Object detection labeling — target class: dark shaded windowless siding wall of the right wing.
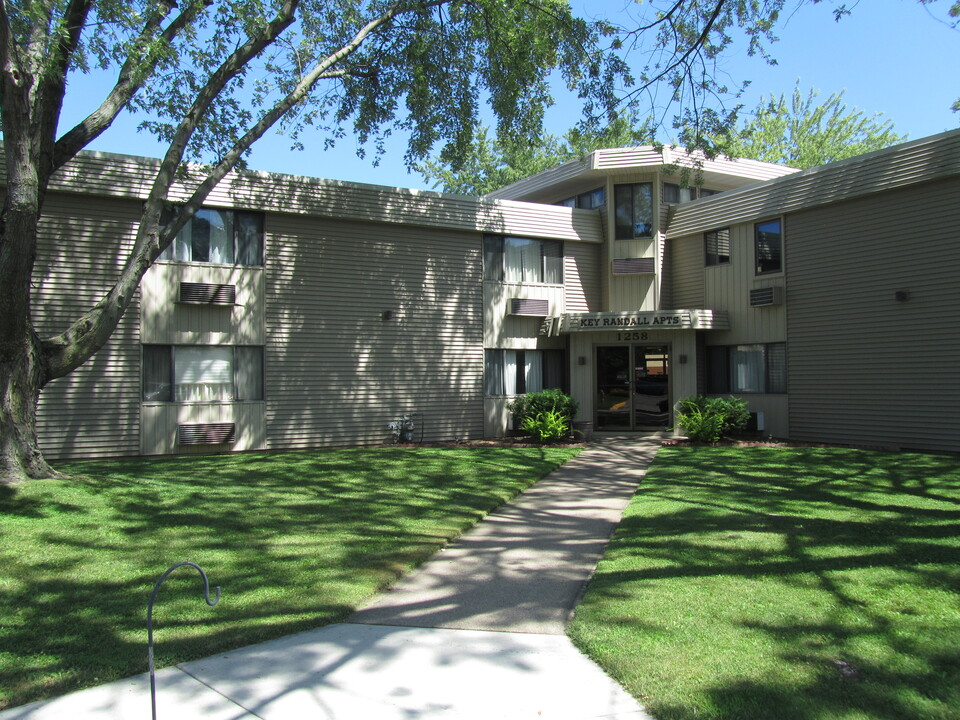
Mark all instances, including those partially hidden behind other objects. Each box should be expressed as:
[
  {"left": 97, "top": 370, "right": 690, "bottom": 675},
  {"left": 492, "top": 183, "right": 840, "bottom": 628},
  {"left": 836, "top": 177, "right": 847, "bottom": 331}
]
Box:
[{"left": 786, "top": 177, "right": 960, "bottom": 452}]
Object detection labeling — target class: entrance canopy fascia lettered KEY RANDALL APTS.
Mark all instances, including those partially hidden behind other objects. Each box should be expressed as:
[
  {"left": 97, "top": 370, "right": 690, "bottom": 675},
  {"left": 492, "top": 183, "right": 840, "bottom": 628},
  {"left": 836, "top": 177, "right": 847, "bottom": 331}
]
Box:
[{"left": 540, "top": 309, "right": 730, "bottom": 336}]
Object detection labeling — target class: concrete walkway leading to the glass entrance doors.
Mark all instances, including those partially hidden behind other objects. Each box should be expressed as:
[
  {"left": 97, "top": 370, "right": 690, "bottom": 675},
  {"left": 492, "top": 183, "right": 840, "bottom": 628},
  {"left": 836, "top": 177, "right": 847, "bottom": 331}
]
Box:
[{"left": 0, "top": 435, "right": 661, "bottom": 720}]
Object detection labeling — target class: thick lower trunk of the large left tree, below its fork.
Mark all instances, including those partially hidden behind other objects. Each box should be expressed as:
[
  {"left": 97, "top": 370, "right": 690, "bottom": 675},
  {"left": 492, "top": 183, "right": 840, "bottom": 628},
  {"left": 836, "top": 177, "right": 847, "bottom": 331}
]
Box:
[{"left": 0, "top": 332, "right": 59, "bottom": 485}]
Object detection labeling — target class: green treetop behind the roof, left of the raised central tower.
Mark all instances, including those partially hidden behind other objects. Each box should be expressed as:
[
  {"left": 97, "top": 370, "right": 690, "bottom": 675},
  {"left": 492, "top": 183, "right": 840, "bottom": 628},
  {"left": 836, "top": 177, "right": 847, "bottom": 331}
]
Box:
[{"left": 416, "top": 118, "right": 649, "bottom": 195}]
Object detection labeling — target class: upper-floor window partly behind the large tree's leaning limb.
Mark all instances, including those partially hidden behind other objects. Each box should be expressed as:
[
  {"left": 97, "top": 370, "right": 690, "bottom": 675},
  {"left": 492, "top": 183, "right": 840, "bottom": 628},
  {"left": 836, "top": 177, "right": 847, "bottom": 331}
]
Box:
[{"left": 160, "top": 208, "right": 263, "bottom": 265}]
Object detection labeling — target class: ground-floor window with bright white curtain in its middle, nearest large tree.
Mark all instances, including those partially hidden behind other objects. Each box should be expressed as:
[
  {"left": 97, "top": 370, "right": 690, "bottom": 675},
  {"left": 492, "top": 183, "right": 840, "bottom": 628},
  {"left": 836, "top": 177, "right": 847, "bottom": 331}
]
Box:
[{"left": 143, "top": 345, "right": 263, "bottom": 402}]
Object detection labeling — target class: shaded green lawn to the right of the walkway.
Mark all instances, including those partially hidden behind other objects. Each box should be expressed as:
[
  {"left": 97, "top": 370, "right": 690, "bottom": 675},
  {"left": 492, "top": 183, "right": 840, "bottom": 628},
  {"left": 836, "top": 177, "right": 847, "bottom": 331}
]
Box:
[{"left": 569, "top": 447, "right": 960, "bottom": 720}]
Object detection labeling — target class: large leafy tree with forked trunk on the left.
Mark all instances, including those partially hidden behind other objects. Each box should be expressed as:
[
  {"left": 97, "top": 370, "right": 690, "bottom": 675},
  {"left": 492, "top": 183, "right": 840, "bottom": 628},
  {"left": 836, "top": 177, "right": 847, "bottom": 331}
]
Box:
[{"left": 0, "top": 0, "right": 625, "bottom": 482}]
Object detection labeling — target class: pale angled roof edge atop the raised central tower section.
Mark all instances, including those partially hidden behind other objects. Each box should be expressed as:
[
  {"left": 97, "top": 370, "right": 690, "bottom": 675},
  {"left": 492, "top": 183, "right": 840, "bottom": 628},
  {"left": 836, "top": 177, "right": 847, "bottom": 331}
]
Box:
[{"left": 484, "top": 145, "right": 798, "bottom": 202}]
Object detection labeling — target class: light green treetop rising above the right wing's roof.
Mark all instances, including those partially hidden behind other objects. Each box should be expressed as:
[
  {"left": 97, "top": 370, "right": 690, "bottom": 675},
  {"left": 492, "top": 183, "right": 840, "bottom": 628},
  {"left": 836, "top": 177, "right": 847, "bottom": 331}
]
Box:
[{"left": 725, "top": 87, "right": 905, "bottom": 168}]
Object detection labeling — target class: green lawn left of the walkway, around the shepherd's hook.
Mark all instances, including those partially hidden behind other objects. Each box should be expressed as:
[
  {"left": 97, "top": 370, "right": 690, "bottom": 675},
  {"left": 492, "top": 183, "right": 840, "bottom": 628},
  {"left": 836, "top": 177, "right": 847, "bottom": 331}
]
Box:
[{"left": 0, "top": 448, "right": 576, "bottom": 708}]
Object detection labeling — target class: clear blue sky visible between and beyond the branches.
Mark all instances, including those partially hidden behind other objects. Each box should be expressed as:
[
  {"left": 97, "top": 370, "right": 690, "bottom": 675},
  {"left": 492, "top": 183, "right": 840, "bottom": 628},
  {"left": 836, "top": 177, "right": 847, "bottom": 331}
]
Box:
[{"left": 62, "top": 0, "right": 960, "bottom": 188}]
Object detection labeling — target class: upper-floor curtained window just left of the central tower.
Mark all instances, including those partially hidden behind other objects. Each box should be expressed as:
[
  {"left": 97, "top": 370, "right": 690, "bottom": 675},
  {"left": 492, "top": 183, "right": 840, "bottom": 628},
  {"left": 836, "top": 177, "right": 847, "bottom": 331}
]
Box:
[{"left": 483, "top": 235, "right": 563, "bottom": 285}]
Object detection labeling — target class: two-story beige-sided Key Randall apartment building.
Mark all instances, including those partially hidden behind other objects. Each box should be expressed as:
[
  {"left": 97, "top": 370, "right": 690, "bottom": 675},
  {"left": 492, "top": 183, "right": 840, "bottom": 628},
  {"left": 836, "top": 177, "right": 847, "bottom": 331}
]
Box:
[{"left": 28, "top": 132, "right": 960, "bottom": 459}]
